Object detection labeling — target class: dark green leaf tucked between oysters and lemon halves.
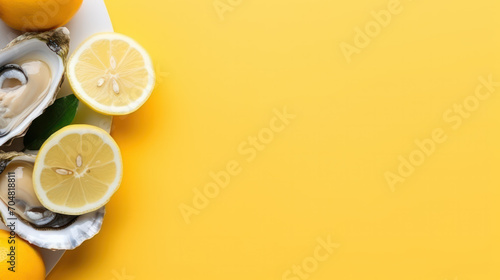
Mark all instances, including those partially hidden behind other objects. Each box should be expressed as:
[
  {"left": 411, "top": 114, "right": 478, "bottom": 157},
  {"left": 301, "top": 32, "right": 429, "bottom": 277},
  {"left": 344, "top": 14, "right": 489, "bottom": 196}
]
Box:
[{"left": 24, "top": 94, "right": 78, "bottom": 150}]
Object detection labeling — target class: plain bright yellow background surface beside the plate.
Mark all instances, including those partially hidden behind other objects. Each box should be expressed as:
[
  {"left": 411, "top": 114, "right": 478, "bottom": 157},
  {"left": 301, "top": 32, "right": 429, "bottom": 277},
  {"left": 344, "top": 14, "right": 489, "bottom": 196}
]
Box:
[{"left": 48, "top": 0, "right": 500, "bottom": 280}]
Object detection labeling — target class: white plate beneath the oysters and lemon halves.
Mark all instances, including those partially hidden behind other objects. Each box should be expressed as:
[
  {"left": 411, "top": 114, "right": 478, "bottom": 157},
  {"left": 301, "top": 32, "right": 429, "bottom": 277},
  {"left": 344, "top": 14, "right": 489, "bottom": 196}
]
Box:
[{"left": 0, "top": 0, "right": 113, "bottom": 275}]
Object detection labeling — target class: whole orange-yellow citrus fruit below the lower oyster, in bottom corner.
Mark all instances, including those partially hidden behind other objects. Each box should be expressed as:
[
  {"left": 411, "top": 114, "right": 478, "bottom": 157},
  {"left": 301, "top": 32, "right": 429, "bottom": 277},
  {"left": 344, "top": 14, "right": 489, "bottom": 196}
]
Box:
[{"left": 0, "top": 230, "right": 45, "bottom": 280}]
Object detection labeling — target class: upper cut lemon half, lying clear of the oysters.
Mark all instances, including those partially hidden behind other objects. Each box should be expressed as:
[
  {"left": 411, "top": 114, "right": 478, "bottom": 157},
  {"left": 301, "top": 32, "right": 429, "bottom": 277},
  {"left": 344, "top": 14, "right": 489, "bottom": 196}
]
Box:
[{"left": 67, "top": 33, "right": 155, "bottom": 115}]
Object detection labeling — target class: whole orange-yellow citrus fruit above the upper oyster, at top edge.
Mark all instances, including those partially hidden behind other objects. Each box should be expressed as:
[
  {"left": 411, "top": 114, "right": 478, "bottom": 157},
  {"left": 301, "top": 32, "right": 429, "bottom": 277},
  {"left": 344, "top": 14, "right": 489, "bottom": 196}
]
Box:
[{"left": 0, "top": 0, "right": 83, "bottom": 31}]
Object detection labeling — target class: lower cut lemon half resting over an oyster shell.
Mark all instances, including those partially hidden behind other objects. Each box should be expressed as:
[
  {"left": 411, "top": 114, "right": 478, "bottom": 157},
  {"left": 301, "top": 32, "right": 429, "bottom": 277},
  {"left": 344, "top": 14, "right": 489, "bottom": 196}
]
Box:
[{"left": 33, "top": 125, "right": 123, "bottom": 215}]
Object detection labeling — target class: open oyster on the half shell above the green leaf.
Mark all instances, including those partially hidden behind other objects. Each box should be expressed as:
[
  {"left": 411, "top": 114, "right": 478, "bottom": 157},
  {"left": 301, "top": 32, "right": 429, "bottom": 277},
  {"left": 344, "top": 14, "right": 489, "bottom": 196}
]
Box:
[{"left": 0, "top": 27, "right": 69, "bottom": 145}]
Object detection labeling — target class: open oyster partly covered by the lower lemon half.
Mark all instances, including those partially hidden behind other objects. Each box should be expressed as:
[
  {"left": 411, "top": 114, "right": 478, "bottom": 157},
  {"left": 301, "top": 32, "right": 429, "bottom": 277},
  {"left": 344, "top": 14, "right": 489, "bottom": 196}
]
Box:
[{"left": 0, "top": 152, "right": 104, "bottom": 250}]
